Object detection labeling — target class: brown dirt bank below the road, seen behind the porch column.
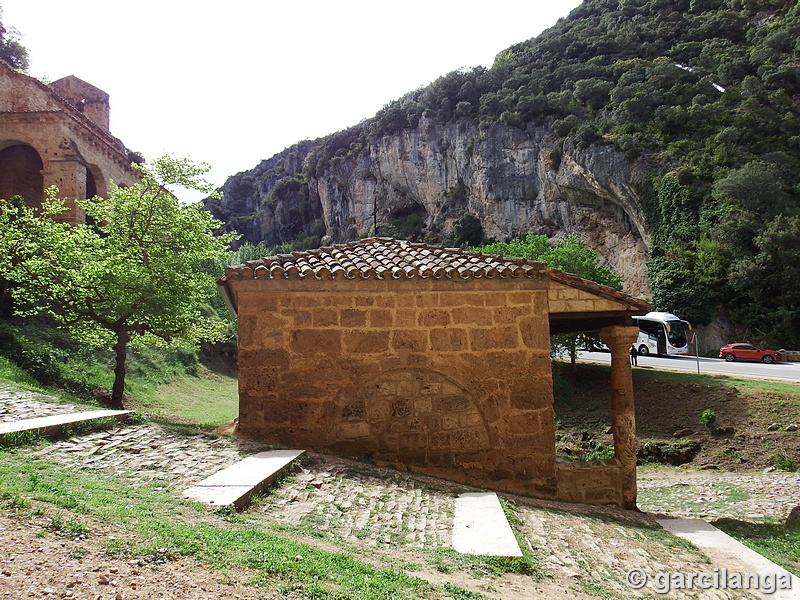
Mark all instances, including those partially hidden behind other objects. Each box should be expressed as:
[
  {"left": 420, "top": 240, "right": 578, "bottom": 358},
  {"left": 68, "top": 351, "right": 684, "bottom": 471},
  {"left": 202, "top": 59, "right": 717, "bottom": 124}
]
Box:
[{"left": 556, "top": 364, "right": 800, "bottom": 472}]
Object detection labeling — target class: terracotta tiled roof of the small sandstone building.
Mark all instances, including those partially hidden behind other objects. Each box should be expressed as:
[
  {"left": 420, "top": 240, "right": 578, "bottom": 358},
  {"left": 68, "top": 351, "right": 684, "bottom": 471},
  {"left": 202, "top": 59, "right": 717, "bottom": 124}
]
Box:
[{"left": 220, "top": 238, "right": 651, "bottom": 310}]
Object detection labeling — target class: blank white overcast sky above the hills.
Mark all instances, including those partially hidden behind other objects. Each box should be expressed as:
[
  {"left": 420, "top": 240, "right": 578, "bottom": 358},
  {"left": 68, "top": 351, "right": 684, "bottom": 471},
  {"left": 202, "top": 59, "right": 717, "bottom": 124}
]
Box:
[{"left": 0, "top": 0, "right": 581, "bottom": 200}]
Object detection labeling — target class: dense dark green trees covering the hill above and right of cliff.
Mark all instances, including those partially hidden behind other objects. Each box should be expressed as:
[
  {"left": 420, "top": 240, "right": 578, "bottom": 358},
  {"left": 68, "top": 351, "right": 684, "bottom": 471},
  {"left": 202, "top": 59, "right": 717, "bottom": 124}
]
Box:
[{"left": 296, "top": 0, "right": 800, "bottom": 347}]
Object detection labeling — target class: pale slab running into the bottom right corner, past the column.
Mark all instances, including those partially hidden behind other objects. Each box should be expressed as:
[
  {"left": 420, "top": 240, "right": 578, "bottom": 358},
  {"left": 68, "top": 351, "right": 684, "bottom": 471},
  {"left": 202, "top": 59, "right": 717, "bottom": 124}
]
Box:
[{"left": 658, "top": 519, "right": 800, "bottom": 600}]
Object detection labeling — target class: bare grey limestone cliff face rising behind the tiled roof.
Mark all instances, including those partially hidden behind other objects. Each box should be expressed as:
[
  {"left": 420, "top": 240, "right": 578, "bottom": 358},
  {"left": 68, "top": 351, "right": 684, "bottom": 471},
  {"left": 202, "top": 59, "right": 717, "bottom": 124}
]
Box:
[{"left": 207, "top": 118, "right": 649, "bottom": 296}]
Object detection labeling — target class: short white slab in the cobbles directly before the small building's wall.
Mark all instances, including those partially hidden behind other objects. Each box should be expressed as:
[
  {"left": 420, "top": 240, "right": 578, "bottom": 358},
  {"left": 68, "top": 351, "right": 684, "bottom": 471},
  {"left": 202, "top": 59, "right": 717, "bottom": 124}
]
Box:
[{"left": 452, "top": 492, "right": 522, "bottom": 557}]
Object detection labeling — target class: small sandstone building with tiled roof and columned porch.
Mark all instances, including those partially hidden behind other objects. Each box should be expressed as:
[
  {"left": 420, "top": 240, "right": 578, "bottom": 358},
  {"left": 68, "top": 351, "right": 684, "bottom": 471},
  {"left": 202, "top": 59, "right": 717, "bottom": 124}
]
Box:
[{"left": 220, "top": 239, "right": 651, "bottom": 508}]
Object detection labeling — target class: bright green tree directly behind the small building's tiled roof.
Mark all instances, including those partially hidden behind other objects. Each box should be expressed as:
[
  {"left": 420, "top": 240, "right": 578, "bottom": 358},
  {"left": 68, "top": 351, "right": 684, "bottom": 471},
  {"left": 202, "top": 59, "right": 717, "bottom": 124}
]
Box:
[{"left": 474, "top": 233, "right": 622, "bottom": 365}]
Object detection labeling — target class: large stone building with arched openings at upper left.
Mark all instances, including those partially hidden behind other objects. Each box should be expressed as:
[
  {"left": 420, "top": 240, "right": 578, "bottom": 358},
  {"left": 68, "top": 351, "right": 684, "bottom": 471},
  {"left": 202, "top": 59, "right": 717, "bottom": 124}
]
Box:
[{"left": 0, "top": 61, "right": 137, "bottom": 223}]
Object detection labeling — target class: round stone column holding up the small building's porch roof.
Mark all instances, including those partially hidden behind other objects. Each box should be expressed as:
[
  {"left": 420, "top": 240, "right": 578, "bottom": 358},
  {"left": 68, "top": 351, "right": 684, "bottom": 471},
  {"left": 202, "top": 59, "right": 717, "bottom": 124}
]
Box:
[{"left": 600, "top": 326, "right": 639, "bottom": 510}]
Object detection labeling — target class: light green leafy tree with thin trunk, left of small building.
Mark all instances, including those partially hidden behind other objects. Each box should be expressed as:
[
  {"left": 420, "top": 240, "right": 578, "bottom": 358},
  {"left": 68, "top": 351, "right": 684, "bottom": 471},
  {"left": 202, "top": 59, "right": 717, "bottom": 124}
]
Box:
[{"left": 0, "top": 157, "right": 238, "bottom": 407}]
